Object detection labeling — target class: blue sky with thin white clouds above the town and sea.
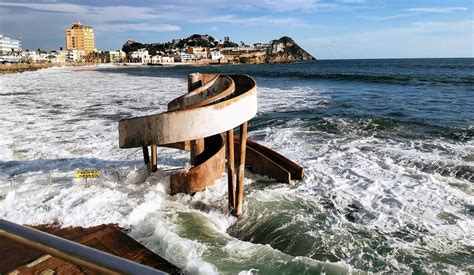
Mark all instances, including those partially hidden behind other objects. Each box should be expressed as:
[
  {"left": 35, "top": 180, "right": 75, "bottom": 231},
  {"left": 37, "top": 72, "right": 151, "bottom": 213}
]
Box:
[{"left": 0, "top": 0, "right": 474, "bottom": 59}]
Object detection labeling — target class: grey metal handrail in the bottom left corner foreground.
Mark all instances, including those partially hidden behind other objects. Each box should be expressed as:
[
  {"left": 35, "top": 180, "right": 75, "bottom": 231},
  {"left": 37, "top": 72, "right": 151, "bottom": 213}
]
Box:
[{"left": 0, "top": 219, "right": 167, "bottom": 274}]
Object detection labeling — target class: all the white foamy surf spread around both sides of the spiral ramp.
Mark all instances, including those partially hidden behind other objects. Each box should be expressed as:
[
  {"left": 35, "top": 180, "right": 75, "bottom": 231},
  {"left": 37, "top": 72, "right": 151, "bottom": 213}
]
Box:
[{"left": 0, "top": 68, "right": 474, "bottom": 274}]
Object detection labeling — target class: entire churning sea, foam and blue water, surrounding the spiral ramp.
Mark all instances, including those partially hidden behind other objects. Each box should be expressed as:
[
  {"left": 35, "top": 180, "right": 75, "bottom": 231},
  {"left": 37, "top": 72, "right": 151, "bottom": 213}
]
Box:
[{"left": 0, "top": 58, "right": 474, "bottom": 274}]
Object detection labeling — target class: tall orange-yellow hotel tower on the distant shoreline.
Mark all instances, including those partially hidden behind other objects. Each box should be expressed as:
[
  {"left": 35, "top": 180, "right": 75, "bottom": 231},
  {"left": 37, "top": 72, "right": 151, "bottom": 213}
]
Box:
[{"left": 66, "top": 22, "right": 96, "bottom": 54}]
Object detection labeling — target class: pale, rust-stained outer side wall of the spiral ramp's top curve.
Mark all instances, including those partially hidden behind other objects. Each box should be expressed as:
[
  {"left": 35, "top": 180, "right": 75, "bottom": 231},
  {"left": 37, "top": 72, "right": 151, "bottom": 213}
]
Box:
[{"left": 119, "top": 76, "right": 257, "bottom": 148}]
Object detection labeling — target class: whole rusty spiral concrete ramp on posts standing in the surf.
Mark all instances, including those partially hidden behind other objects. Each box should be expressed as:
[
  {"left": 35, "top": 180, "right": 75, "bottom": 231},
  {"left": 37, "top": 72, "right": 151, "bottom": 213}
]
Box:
[{"left": 119, "top": 74, "right": 304, "bottom": 215}]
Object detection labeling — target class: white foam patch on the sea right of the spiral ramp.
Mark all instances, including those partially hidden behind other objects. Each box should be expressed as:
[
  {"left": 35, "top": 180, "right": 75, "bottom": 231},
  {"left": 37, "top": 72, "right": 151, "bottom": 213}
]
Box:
[{"left": 244, "top": 120, "right": 474, "bottom": 272}]
